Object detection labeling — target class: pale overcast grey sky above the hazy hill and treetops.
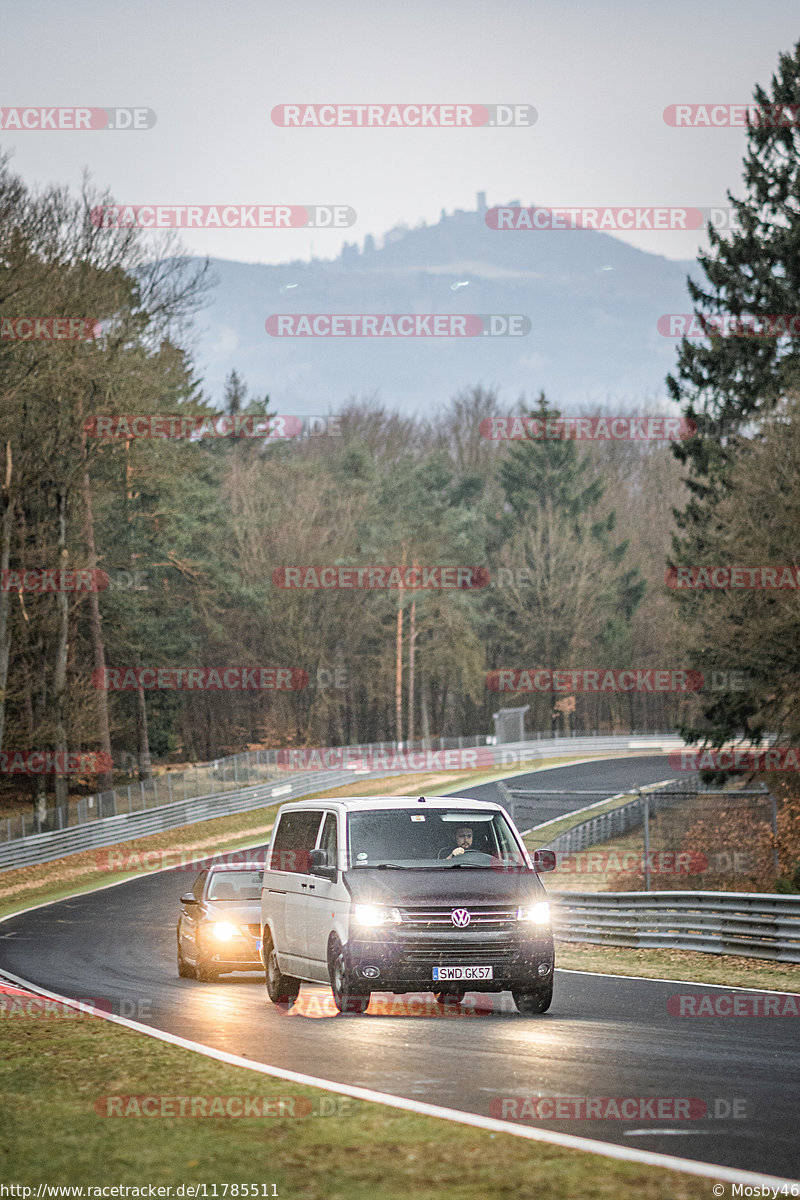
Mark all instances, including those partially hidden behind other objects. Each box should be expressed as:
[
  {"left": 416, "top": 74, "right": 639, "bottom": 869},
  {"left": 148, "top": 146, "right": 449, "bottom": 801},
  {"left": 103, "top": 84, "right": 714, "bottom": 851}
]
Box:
[{"left": 0, "top": 0, "right": 800, "bottom": 263}]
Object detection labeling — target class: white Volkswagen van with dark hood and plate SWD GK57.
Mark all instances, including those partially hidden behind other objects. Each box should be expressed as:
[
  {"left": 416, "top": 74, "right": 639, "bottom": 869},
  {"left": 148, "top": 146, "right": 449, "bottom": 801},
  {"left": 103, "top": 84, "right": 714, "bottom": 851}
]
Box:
[{"left": 260, "top": 796, "right": 555, "bottom": 1015}]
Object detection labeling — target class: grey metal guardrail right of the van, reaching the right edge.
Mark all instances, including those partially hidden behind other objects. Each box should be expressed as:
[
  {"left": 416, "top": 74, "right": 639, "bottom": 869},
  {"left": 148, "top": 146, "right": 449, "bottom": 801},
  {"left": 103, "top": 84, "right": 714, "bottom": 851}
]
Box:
[{"left": 549, "top": 892, "right": 800, "bottom": 962}]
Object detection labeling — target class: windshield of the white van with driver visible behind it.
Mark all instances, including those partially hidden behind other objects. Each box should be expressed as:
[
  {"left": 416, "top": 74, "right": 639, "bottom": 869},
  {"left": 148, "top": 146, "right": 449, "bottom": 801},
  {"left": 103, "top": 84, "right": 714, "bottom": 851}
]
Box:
[{"left": 348, "top": 808, "right": 527, "bottom": 870}]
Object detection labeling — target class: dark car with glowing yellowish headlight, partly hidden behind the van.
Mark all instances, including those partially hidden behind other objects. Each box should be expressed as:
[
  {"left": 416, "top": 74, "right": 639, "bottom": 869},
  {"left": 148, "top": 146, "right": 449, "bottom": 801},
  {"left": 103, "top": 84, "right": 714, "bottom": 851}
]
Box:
[{"left": 178, "top": 864, "right": 264, "bottom": 983}]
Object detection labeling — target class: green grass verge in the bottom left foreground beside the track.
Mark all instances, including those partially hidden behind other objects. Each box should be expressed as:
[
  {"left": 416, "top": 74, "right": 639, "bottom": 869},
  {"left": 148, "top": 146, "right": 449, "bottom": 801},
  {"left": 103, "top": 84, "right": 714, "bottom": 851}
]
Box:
[{"left": 0, "top": 1016, "right": 710, "bottom": 1200}]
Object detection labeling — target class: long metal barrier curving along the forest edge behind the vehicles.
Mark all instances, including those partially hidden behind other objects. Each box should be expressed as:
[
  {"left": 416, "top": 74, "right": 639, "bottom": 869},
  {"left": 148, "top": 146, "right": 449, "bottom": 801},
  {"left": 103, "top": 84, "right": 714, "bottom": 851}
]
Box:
[{"left": 0, "top": 734, "right": 684, "bottom": 871}]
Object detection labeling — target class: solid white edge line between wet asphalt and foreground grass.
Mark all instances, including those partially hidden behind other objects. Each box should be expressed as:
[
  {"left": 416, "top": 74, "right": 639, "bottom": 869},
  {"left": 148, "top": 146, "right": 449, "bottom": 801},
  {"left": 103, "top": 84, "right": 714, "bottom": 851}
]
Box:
[{"left": 0, "top": 971, "right": 796, "bottom": 1188}]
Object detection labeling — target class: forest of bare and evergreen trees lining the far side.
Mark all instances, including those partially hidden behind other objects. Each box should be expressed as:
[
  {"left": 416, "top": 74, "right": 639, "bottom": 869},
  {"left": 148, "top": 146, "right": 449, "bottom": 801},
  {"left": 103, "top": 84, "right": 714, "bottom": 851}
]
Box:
[{"left": 0, "top": 39, "right": 800, "bottom": 825}]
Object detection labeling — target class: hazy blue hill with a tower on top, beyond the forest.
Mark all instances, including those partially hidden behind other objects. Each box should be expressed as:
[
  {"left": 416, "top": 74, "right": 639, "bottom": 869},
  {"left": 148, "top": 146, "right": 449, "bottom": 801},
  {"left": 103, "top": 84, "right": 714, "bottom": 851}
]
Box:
[{"left": 189, "top": 198, "right": 698, "bottom": 414}]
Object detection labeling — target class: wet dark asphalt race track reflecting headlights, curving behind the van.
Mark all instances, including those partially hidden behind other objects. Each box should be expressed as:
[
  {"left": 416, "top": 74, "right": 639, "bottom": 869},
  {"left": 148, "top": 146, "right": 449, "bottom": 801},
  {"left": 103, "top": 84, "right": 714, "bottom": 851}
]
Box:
[{"left": 0, "top": 756, "right": 800, "bottom": 1178}]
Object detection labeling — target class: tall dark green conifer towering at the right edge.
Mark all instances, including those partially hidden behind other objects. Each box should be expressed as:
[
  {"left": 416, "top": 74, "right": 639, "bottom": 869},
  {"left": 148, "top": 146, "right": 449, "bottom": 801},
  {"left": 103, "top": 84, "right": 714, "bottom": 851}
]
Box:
[{"left": 667, "top": 42, "right": 800, "bottom": 744}]
